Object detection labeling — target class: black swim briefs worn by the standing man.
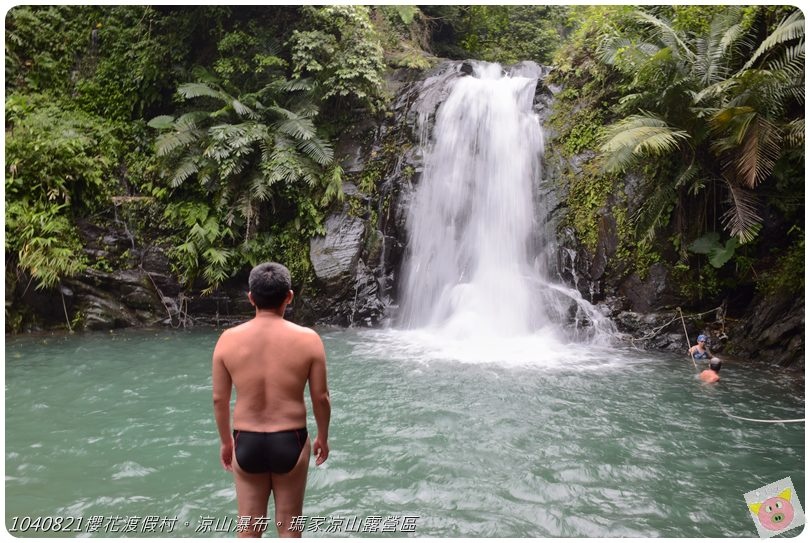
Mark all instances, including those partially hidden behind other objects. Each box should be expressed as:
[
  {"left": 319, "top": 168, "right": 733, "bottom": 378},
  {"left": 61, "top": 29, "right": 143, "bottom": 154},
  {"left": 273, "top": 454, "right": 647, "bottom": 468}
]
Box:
[{"left": 233, "top": 428, "right": 307, "bottom": 473}]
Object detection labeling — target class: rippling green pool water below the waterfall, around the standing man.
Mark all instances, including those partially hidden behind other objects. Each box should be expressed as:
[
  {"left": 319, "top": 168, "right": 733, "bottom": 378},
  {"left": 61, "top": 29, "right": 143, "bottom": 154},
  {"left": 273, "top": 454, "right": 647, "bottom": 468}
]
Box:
[{"left": 5, "top": 330, "right": 805, "bottom": 537}]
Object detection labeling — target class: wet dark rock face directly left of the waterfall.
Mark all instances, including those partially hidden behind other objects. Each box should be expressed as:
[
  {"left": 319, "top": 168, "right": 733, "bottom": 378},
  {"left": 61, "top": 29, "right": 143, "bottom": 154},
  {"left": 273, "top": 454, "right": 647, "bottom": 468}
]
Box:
[{"left": 296, "top": 61, "right": 482, "bottom": 326}]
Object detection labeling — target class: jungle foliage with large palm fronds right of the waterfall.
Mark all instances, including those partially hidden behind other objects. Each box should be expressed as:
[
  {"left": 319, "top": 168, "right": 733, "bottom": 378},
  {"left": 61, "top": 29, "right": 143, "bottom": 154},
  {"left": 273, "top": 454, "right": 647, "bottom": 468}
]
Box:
[{"left": 554, "top": 6, "right": 804, "bottom": 302}]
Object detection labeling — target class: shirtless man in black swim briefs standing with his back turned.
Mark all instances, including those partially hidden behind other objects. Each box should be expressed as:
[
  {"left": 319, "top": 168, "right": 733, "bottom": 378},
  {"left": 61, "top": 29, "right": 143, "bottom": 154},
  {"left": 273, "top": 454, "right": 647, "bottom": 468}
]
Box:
[{"left": 212, "top": 263, "right": 331, "bottom": 537}]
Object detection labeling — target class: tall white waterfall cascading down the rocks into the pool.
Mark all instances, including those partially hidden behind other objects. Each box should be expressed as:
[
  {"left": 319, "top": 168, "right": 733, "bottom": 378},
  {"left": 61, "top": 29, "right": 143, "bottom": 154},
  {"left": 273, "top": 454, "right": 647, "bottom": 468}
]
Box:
[{"left": 400, "top": 63, "right": 609, "bottom": 341}]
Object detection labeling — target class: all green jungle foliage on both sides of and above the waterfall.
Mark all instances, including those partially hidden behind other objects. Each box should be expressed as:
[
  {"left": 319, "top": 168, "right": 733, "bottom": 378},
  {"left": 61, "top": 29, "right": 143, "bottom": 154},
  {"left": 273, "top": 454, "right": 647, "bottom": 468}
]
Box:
[{"left": 5, "top": 5, "right": 804, "bottom": 324}]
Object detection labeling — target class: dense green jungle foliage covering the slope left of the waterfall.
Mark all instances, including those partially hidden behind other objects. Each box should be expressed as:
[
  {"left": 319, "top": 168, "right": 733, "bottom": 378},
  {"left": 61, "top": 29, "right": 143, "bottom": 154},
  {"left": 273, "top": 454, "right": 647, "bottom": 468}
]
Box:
[{"left": 6, "top": 6, "right": 388, "bottom": 298}]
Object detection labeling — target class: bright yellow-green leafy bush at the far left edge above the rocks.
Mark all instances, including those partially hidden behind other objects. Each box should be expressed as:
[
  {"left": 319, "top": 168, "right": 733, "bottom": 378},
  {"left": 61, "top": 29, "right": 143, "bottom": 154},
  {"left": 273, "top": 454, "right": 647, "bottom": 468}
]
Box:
[{"left": 5, "top": 94, "right": 120, "bottom": 288}]
